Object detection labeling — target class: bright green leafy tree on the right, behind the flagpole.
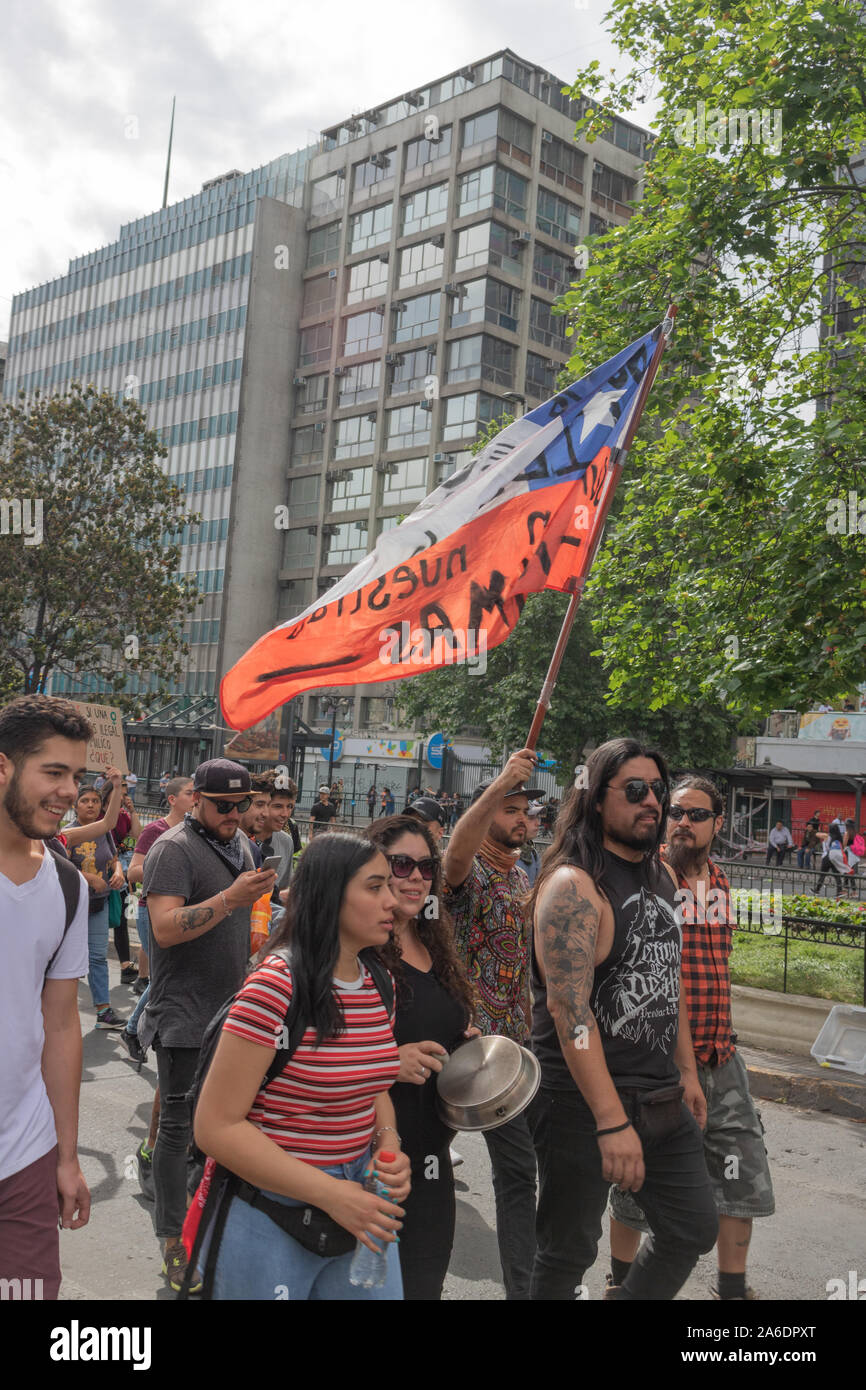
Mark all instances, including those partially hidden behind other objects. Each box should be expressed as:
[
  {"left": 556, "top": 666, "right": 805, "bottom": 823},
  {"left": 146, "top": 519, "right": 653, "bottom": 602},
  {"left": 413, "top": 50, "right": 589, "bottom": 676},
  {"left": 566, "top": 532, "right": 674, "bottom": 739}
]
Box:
[{"left": 563, "top": 0, "right": 866, "bottom": 720}]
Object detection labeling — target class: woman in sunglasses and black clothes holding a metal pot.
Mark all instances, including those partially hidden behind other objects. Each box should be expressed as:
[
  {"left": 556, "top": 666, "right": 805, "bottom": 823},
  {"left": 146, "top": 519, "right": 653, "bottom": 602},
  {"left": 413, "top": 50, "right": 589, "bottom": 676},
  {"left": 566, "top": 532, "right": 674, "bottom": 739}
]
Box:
[{"left": 366, "top": 816, "right": 478, "bottom": 1301}]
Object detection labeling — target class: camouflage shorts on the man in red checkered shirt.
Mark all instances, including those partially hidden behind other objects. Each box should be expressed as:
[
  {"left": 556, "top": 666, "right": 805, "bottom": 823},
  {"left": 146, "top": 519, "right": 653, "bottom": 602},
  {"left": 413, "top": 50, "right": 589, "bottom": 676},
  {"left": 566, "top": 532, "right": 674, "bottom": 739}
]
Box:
[{"left": 610, "top": 1052, "right": 776, "bottom": 1232}]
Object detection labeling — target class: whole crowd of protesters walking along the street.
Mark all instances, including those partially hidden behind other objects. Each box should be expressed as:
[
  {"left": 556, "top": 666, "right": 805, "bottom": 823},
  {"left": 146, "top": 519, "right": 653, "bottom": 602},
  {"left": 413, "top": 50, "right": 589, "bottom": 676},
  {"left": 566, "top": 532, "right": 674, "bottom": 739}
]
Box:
[{"left": 0, "top": 696, "right": 863, "bottom": 1301}]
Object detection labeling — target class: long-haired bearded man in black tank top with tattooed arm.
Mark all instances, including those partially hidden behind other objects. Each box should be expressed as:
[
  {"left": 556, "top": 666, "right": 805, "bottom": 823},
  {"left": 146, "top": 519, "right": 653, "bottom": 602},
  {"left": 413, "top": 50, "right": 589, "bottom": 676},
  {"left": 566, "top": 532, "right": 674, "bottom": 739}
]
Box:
[{"left": 530, "top": 738, "right": 719, "bottom": 1300}]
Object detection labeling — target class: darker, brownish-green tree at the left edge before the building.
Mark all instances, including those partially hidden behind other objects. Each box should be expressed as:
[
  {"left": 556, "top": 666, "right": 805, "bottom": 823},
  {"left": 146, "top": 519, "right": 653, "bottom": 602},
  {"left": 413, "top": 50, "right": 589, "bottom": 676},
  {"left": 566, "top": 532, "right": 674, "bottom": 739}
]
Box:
[{"left": 0, "top": 384, "right": 199, "bottom": 712}]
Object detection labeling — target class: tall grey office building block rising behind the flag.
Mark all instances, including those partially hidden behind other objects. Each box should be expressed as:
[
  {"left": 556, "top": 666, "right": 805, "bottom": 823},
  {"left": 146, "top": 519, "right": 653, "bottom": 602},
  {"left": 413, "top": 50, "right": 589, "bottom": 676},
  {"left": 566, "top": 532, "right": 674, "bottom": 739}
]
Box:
[{"left": 7, "top": 50, "right": 649, "bottom": 730}]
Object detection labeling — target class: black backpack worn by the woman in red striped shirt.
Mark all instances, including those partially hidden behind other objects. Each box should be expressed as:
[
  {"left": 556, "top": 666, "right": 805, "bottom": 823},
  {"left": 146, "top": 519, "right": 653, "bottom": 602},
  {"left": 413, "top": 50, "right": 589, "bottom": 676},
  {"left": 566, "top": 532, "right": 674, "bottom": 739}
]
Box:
[{"left": 178, "top": 947, "right": 393, "bottom": 1300}]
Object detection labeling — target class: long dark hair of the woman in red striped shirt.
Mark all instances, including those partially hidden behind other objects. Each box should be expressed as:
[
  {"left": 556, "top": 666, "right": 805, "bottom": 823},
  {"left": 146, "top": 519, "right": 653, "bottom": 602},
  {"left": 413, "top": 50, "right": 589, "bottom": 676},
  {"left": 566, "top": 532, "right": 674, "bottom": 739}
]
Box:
[{"left": 263, "top": 831, "right": 377, "bottom": 1047}]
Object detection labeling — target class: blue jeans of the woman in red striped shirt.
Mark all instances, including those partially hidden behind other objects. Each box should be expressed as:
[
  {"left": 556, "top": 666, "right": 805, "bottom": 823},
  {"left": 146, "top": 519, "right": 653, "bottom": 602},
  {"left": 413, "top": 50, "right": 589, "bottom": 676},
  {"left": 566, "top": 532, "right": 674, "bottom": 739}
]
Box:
[{"left": 209, "top": 1151, "right": 403, "bottom": 1302}]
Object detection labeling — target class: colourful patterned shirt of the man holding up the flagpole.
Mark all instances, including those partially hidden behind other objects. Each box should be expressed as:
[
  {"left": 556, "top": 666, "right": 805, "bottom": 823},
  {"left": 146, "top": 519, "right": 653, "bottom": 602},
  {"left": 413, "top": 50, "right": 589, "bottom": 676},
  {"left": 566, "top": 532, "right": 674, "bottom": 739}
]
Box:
[{"left": 445, "top": 855, "right": 531, "bottom": 1044}]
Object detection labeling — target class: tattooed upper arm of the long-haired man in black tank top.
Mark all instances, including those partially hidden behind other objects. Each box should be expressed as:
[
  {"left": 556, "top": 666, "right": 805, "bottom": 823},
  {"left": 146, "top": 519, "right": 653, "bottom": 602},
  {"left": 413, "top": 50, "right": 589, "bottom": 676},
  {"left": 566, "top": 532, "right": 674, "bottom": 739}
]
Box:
[{"left": 538, "top": 878, "right": 599, "bottom": 1047}]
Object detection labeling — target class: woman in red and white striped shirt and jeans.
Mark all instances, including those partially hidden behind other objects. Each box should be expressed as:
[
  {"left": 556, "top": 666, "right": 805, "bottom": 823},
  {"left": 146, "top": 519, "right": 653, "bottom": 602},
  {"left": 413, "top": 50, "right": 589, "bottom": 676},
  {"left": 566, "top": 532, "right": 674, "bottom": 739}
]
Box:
[{"left": 195, "top": 834, "right": 410, "bottom": 1301}]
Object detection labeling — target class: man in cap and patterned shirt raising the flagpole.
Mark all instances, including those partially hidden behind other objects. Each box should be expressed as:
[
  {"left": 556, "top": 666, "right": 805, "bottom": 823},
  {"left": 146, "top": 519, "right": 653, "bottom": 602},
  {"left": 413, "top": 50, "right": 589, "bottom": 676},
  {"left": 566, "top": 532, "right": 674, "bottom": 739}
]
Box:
[{"left": 447, "top": 748, "right": 541, "bottom": 1300}]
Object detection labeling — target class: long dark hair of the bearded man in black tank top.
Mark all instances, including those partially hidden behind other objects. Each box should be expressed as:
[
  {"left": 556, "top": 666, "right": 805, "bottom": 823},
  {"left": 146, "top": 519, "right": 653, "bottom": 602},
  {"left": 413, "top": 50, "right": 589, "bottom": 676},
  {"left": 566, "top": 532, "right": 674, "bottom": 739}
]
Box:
[{"left": 530, "top": 738, "right": 669, "bottom": 909}]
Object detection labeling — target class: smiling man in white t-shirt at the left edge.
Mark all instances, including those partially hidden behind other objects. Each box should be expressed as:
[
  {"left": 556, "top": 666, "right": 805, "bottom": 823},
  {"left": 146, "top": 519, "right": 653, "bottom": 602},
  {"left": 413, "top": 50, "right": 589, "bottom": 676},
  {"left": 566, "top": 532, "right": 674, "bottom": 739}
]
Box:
[{"left": 0, "top": 695, "right": 93, "bottom": 1298}]
